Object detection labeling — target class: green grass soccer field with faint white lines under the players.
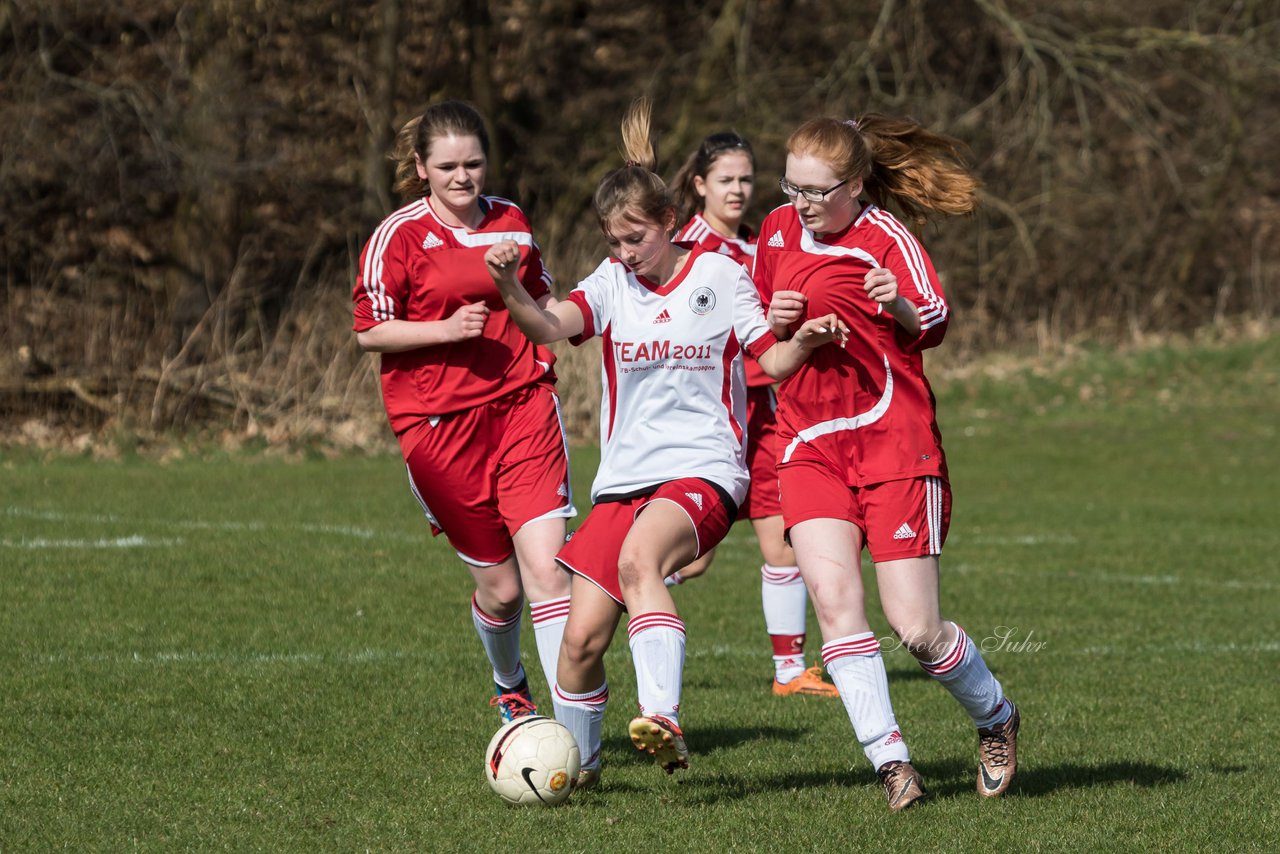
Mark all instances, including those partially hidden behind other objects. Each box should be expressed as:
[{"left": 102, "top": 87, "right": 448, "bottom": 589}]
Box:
[{"left": 0, "top": 337, "right": 1280, "bottom": 853}]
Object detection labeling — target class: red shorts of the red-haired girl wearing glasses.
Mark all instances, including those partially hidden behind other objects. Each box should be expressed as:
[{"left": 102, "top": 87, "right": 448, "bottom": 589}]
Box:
[{"left": 778, "top": 461, "right": 951, "bottom": 563}]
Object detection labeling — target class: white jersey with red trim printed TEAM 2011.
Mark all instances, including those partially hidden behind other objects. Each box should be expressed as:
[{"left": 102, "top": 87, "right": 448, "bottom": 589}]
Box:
[{"left": 568, "top": 247, "right": 777, "bottom": 504}]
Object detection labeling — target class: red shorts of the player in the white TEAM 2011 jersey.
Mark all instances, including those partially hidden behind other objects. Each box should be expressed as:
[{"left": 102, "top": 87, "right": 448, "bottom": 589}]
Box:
[{"left": 556, "top": 478, "right": 733, "bottom": 607}]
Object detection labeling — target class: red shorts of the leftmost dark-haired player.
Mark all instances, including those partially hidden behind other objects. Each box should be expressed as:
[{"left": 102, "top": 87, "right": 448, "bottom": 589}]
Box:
[{"left": 401, "top": 384, "right": 575, "bottom": 566}]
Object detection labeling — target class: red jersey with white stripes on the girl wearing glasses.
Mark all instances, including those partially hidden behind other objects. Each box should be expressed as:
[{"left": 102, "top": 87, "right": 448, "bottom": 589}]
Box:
[{"left": 753, "top": 205, "right": 950, "bottom": 487}]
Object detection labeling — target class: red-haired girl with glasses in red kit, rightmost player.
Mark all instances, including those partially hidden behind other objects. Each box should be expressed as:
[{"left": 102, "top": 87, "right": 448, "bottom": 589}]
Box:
[{"left": 754, "top": 115, "right": 1019, "bottom": 810}]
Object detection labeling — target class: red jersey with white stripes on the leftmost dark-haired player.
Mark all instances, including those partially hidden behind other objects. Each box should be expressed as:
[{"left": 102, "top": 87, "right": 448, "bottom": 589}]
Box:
[{"left": 352, "top": 196, "right": 556, "bottom": 435}]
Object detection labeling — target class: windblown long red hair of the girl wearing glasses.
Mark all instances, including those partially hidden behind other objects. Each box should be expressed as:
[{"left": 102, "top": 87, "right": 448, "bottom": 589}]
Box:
[{"left": 787, "top": 113, "right": 980, "bottom": 224}]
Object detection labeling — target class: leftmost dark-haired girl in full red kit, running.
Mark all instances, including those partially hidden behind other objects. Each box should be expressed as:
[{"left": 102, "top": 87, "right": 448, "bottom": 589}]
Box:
[{"left": 353, "top": 101, "right": 573, "bottom": 721}]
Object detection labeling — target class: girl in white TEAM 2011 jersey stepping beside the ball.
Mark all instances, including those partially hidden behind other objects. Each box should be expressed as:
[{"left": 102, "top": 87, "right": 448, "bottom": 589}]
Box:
[{"left": 485, "top": 99, "right": 841, "bottom": 786}]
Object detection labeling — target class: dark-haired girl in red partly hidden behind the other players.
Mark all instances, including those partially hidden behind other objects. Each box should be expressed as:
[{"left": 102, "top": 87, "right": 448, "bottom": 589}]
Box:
[{"left": 667, "top": 132, "right": 837, "bottom": 697}]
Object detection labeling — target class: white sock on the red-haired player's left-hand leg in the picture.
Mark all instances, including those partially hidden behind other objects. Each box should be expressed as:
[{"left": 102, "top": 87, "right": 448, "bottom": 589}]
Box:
[{"left": 822, "top": 631, "right": 910, "bottom": 771}]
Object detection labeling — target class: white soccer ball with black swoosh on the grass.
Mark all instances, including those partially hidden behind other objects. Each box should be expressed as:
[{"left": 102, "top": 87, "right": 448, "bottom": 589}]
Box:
[{"left": 484, "top": 714, "right": 581, "bottom": 805}]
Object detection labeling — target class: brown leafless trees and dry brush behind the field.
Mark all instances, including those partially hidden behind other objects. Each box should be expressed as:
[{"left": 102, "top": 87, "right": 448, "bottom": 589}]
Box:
[{"left": 0, "top": 0, "right": 1280, "bottom": 447}]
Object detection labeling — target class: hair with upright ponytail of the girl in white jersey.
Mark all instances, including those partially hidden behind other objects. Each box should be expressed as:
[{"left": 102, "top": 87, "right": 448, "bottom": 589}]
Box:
[{"left": 593, "top": 97, "right": 676, "bottom": 230}]
